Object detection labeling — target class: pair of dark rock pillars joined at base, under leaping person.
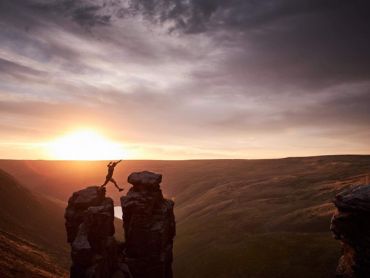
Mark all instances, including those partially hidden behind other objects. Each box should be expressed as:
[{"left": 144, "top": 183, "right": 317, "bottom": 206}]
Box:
[{"left": 65, "top": 171, "right": 175, "bottom": 278}]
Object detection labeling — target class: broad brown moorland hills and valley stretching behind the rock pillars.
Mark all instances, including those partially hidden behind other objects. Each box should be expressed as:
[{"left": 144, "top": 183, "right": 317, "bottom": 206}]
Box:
[{"left": 0, "top": 155, "right": 370, "bottom": 278}]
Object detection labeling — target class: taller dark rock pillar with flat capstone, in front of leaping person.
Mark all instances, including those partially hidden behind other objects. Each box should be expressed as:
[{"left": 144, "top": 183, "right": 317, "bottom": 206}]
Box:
[{"left": 121, "top": 171, "right": 175, "bottom": 278}]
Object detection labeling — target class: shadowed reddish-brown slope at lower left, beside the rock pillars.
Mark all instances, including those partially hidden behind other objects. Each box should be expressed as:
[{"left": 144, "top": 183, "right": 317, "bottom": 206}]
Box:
[{"left": 0, "top": 170, "right": 69, "bottom": 277}]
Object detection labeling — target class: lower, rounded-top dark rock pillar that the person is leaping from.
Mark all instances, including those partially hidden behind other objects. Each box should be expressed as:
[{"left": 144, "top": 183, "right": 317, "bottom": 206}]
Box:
[{"left": 65, "top": 186, "right": 131, "bottom": 278}]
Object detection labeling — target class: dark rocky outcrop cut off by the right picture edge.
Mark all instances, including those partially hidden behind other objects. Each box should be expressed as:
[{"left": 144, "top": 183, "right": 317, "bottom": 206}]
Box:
[{"left": 330, "top": 186, "right": 370, "bottom": 278}]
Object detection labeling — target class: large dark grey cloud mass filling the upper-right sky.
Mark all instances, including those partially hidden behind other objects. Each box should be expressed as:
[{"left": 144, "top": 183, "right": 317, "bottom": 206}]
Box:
[{"left": 126, "top": 0, "right": 370, "bottom": 88}]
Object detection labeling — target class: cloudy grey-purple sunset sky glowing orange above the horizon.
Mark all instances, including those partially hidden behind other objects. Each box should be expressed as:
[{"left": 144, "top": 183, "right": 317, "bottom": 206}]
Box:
[{"left": 0, "top": 0, "right": 370, "bottom": 159}]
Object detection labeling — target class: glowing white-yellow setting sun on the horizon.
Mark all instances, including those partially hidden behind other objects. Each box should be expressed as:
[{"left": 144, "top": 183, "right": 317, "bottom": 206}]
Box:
[{"left": 47, "top": 130, "right": 126, "bottom": 160}]
